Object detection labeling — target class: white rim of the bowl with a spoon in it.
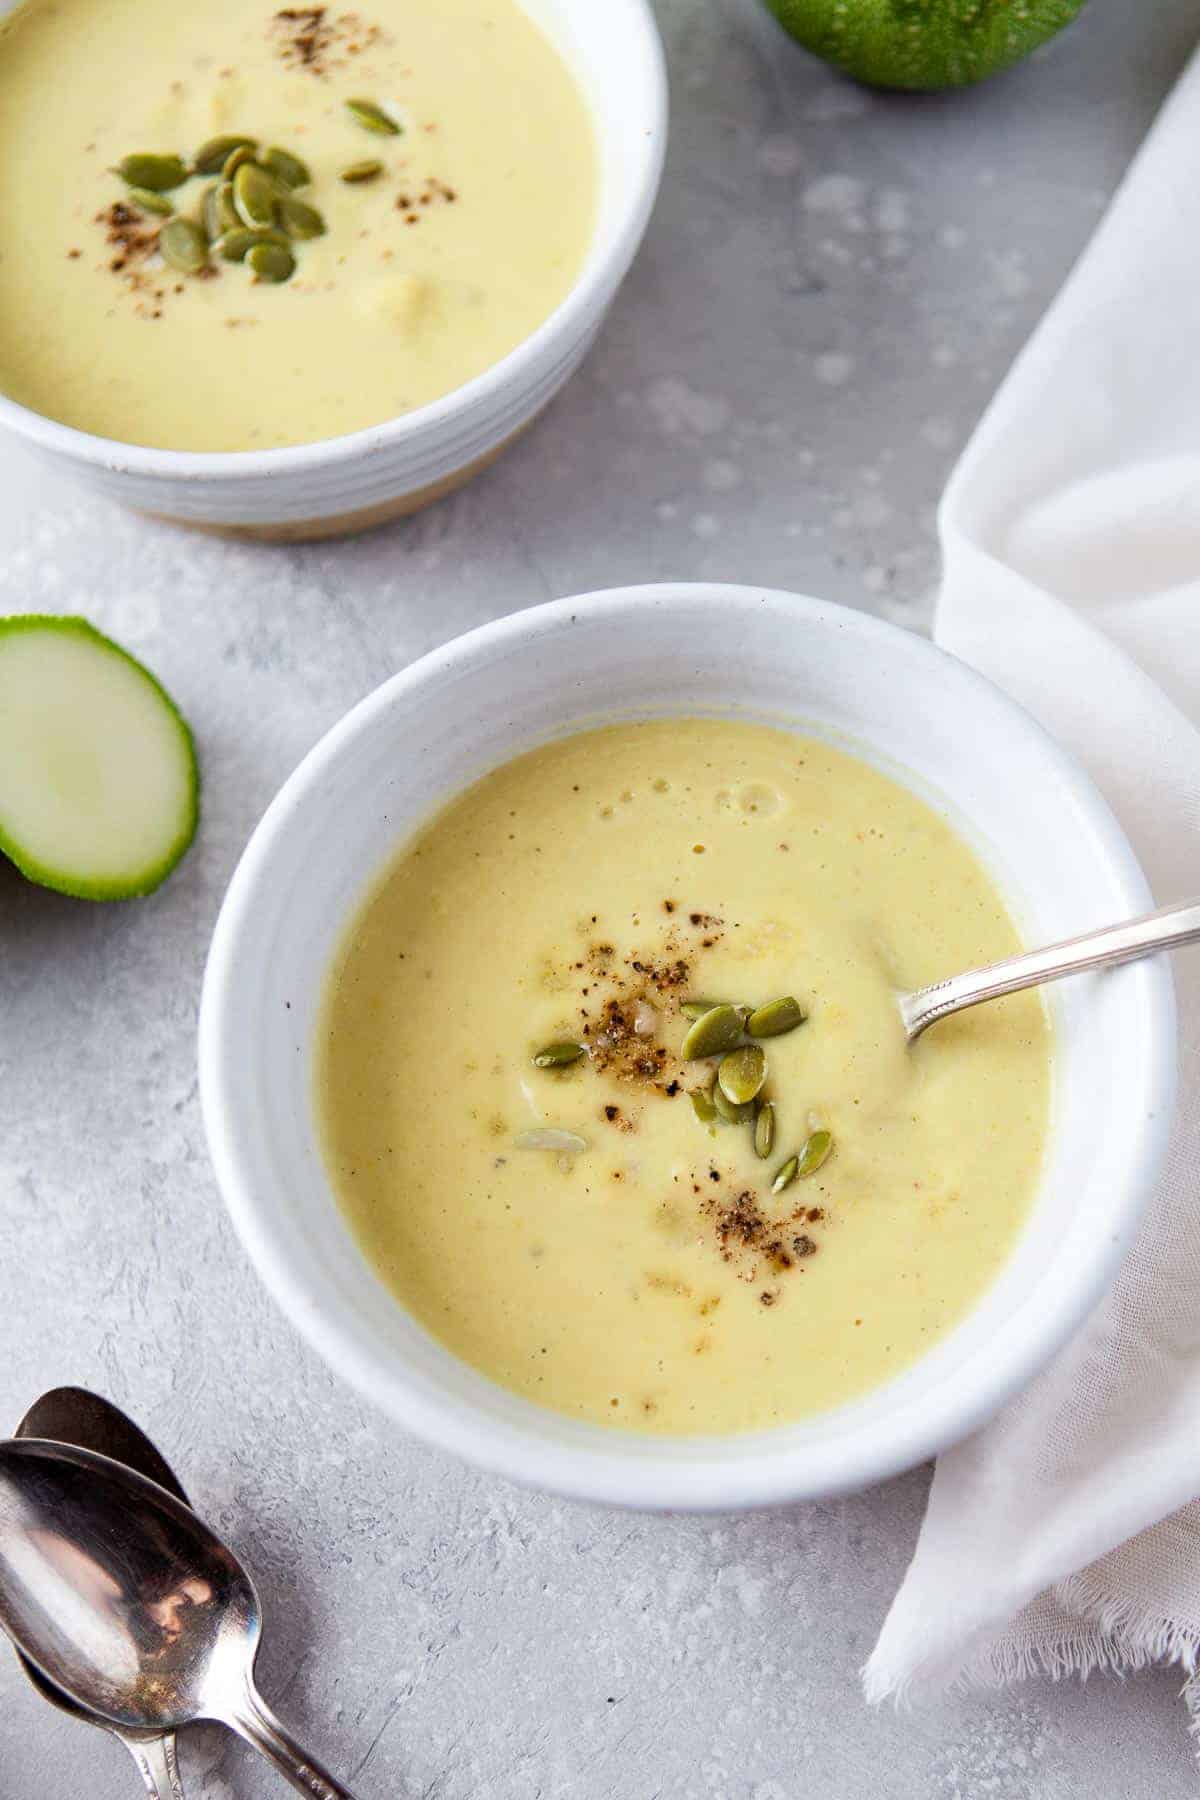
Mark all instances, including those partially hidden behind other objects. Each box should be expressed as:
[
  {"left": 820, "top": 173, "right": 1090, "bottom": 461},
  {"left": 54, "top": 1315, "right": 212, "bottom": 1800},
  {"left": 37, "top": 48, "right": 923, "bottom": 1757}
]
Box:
[{"left": 198, "top": 581, "right": 1177, "bottom": 1512}]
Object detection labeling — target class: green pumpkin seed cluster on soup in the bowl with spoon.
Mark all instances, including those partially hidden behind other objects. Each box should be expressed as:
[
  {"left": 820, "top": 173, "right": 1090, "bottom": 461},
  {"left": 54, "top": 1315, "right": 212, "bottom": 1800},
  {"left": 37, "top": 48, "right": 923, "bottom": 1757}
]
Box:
[{"left": 680, "top": 994, "right": 833, "bottom": 1193}]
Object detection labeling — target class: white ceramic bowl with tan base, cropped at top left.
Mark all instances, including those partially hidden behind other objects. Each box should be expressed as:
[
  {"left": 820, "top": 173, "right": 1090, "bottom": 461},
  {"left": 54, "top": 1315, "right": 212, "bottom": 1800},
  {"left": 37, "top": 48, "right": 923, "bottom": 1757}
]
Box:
[{"left": 0, "top": 0, "right": 667, "bottom": 542}]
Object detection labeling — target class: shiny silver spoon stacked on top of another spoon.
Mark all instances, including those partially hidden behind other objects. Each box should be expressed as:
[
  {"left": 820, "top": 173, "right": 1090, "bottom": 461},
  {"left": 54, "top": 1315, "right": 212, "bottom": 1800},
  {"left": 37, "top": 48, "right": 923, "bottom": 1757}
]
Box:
[{"left": 0, "top": 1438, "right": 354, "bottom": 1800}]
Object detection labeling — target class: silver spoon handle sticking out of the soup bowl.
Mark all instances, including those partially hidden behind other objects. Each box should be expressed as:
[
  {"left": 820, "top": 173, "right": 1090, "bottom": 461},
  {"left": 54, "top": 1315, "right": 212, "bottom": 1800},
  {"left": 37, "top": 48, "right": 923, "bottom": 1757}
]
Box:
[{"left": 898, "top": 900, "right": 1200, "bottom": 1044}]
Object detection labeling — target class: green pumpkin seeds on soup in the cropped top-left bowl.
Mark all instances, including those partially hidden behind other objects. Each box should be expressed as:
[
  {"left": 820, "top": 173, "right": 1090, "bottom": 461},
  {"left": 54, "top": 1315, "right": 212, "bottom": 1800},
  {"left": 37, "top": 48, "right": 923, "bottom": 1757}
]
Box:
[{"left": 115, "top": 99, "right": 403, "bottom": 283}]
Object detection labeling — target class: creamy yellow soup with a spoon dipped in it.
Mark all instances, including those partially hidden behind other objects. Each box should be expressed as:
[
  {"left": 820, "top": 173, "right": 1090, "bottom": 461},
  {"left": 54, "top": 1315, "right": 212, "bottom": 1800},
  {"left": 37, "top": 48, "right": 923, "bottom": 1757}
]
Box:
[{"left": 317, "top": 720, "right": 1051, "bottom": 1433}]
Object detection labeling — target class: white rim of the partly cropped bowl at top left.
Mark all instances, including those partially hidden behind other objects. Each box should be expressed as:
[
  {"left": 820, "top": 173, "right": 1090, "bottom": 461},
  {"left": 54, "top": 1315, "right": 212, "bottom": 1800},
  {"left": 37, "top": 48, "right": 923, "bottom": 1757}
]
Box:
[{"left": 0, "top": 0, "right": 669, "bottom": 482}]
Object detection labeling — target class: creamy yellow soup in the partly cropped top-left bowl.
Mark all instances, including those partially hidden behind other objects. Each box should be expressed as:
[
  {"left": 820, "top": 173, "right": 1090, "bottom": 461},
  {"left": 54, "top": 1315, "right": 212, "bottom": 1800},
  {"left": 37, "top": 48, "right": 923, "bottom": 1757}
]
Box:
[{"left": 0, "top": 0, "right": 597, "bottom": 450}]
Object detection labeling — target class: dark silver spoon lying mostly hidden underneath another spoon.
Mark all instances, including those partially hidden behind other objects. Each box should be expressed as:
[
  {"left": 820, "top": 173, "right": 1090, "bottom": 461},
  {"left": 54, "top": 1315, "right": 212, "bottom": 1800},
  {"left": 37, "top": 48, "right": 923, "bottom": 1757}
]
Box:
[{"left": 16, "top": 1388, "right": 187, "bottom": 1800}]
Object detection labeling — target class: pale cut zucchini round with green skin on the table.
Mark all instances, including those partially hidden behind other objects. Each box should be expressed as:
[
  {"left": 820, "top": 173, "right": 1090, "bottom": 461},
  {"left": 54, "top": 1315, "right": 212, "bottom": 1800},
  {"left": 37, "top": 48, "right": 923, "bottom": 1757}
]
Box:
[{"left": 0, "top": 614, "right": 200, "bottom": 900}]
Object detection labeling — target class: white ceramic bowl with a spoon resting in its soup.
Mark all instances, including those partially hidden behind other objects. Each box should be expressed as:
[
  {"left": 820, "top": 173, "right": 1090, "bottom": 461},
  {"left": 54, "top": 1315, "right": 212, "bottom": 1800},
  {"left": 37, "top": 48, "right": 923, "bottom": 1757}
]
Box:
[{"left": 200, "top": 585, "right": 1175, "bottom": 1508}]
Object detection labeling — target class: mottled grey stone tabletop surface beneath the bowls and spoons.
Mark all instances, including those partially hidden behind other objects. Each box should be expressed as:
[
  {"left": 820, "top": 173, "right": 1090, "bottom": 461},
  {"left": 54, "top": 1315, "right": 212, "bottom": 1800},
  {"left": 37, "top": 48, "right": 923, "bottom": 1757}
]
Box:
[{"left": 0, "top": 0, "right": 1196, "bottom": 1800}]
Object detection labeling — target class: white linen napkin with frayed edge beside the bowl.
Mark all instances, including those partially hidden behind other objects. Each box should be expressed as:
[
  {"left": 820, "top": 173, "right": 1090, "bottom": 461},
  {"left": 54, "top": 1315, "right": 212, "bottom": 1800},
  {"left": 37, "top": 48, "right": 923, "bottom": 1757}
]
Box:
[{"left": 864, "top": 38, "right": 1200, "bottom": 1699}]
